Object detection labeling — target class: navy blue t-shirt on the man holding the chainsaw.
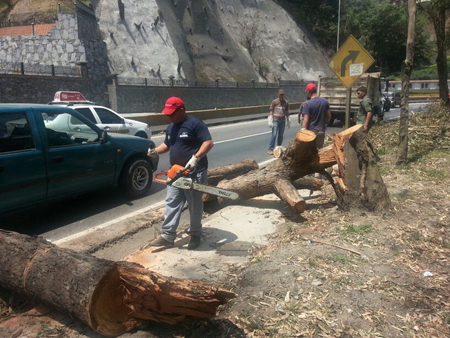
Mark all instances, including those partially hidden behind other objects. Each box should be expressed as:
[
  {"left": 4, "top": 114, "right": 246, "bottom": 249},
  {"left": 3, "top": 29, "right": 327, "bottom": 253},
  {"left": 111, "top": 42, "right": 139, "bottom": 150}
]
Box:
[{"left": 164, "top": 115, "right": 212, "bottom": 171}]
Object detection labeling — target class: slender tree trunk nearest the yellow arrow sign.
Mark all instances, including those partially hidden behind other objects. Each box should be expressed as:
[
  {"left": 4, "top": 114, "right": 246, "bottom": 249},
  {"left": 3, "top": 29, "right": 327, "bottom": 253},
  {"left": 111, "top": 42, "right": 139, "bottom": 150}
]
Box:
[{"left": 397, "top": 0, "right": 416, "bottom": 164}]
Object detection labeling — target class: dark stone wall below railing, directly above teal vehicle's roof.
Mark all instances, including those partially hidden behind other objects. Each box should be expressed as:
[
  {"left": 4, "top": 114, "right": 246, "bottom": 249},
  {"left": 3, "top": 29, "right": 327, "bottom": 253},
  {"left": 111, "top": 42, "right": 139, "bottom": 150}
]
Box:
[{"left": 0, "top": 74, "right": 89, "bottom": 103}]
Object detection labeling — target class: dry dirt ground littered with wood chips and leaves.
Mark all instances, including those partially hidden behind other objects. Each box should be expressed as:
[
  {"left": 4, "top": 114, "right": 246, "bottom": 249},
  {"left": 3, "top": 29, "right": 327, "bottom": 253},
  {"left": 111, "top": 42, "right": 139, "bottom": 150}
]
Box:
[{"left": 0, "top": 107, "right": 450, "bottom": 337}]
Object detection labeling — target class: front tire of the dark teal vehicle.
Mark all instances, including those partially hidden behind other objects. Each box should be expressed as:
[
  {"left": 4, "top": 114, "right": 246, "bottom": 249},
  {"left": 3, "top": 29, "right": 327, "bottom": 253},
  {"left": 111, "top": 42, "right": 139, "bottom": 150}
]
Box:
[{"left": 119, "top": 158, "right": 153, "bottom": 198}]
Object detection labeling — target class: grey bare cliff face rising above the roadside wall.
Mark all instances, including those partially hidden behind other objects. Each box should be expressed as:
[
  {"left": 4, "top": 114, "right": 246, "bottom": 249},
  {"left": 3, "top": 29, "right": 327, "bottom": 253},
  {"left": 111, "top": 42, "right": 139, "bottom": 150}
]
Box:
[{"left": 95, "top": 0, "right": 329, "bottom": 82}]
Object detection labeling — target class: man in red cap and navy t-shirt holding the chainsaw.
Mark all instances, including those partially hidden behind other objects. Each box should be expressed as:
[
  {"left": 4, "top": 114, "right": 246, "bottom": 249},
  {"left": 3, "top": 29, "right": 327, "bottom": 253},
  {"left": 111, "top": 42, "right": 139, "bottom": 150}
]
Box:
[{"left": 149, "top": 97, "right": 214, "bottom": 250}]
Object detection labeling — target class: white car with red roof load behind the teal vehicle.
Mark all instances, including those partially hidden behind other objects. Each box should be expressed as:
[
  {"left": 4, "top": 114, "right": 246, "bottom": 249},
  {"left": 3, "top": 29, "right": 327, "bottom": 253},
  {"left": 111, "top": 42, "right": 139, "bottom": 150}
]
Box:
[{"left": 50, "top": 91, "right": 152, "bottom": 140}]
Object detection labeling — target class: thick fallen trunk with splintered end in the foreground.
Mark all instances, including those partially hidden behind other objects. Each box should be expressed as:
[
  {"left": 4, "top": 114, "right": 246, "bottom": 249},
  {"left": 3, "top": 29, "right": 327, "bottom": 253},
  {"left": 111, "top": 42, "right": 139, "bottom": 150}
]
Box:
[{"left": 0, "top": 230, "right": 235, "bottom": 336}]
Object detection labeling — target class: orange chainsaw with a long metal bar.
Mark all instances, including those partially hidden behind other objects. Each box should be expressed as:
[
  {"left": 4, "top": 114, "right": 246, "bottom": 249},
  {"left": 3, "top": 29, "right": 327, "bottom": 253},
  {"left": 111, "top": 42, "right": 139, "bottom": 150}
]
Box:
[{"left": 155, "top": 164, "right": 239, "bottom": 200}]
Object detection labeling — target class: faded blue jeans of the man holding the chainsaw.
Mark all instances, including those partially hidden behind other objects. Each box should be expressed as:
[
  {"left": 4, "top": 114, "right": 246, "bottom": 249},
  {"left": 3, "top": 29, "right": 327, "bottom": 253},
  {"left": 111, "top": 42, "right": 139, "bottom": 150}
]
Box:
[{"left": 161, "top": 170, "right": 206, "bottom": 243}]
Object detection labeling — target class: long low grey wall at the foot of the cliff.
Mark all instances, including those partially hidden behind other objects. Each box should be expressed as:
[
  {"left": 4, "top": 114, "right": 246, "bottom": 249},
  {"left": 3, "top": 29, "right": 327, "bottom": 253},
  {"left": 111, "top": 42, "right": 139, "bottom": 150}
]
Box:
[{"left": 108, "top": 83, "right": 306, "bottom": 114}]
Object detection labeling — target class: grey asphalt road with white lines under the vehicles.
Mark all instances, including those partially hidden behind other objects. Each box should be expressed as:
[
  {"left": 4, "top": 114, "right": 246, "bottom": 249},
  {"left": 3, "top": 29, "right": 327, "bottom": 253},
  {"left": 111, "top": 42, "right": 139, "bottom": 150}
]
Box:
[{"left": 0, "top": 103, "right": 425, "bottom": 241}]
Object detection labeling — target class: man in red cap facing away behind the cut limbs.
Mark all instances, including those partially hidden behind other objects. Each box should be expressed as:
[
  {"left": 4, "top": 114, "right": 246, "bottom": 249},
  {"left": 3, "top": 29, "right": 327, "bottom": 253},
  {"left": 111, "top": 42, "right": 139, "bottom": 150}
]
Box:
[{"left": 301, "top": 83, "right": 331, "bottom": 149}]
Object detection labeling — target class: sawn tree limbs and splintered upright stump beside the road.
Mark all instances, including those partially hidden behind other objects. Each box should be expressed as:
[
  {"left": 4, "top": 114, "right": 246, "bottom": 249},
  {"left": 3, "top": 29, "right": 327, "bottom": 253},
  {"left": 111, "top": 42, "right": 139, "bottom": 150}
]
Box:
[{"left": 204, "top": 125, "right": 390, "bottom": 213}]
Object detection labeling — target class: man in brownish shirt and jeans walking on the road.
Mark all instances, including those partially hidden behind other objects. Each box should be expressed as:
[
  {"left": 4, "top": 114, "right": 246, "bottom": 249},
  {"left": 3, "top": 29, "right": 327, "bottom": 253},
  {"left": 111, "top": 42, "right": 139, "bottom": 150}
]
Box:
[{"left": 268, "top": 89, "right": 291, "bottom": 154}]
